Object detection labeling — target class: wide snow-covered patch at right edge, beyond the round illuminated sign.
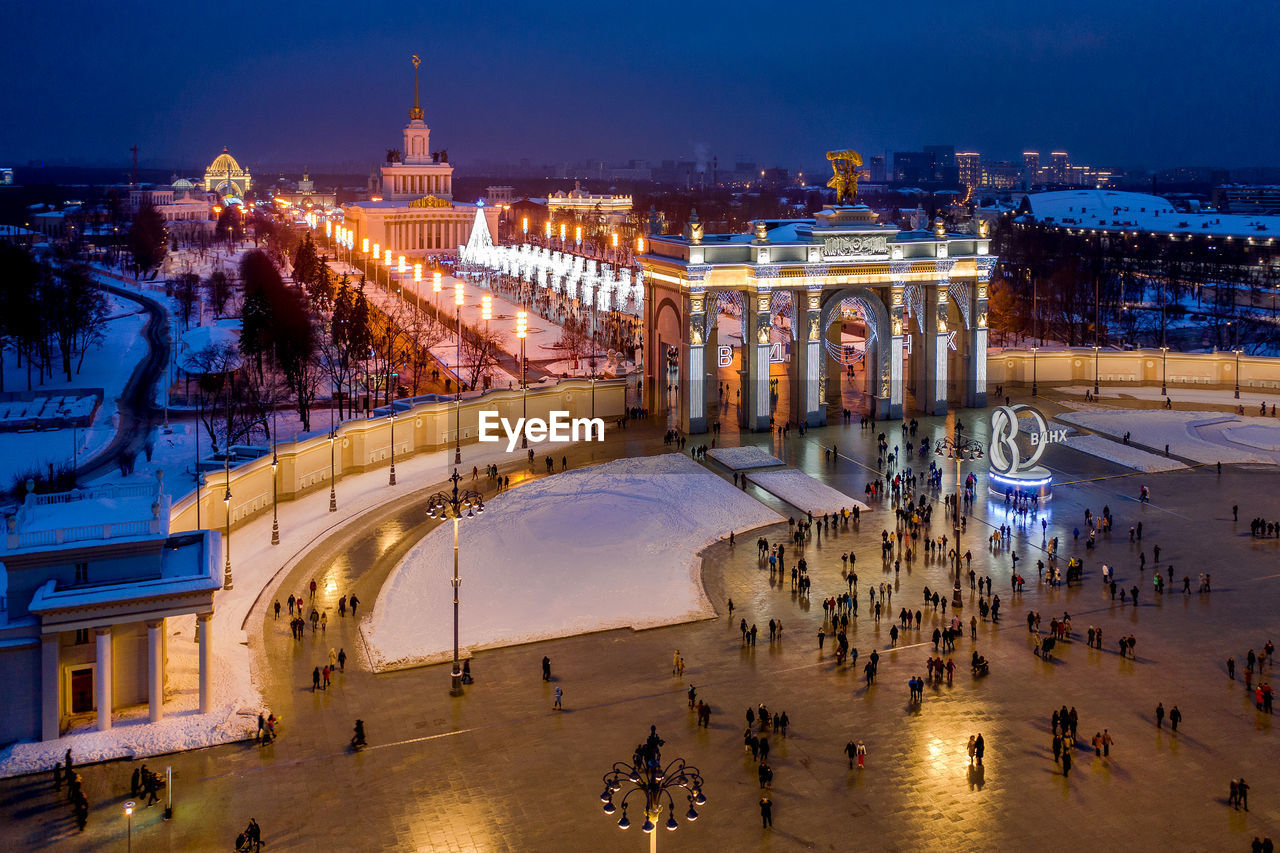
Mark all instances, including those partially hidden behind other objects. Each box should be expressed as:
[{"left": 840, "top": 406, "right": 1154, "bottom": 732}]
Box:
[{"left": 1056, "top": 409, "right": 1280, "bottom": 465}]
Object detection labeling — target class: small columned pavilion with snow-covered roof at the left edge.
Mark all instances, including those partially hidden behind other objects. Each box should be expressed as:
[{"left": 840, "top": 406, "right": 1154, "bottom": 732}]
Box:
[{"left": 0, "top": 475, "right": 221, "bottom": 744}]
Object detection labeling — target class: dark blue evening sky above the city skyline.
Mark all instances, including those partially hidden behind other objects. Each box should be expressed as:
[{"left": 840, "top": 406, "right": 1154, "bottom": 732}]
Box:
[{"left": 0, "top": 0, "right": 1280, "bottom": 169}]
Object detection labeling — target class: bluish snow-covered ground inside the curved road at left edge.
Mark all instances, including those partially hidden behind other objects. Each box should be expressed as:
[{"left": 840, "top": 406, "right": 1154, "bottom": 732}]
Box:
[{"left": 0, "top": 296, "right": 147, "bottom": 488}]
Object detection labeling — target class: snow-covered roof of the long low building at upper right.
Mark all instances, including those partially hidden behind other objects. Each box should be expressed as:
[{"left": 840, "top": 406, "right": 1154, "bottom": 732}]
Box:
[{"left": 1021, "top": 190, "right": 1280, "bottom": 238}]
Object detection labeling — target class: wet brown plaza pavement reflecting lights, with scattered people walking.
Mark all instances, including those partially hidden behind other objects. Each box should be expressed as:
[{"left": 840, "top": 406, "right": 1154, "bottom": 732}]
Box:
[{"left": 0, "top": 389, "right": 1280, "bottom": 850}]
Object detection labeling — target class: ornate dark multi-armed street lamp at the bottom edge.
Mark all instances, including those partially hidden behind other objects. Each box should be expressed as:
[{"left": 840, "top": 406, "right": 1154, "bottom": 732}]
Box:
[{"left": 600, "top": 733, "right": 707, "bottom": 853}]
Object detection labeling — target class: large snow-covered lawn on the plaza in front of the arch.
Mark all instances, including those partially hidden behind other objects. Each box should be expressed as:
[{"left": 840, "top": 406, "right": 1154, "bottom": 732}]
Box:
[{"left": 361, "top": 453, "right": 781, "bottom": 669}]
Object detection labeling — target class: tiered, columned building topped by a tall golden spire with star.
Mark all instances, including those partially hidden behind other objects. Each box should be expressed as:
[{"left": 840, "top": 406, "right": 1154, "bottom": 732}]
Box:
[{"left": 342, "top": 56, "right": 499, "bottom": 260}]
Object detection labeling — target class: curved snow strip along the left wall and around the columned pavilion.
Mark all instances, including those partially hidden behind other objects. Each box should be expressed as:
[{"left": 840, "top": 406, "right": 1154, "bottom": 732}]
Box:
[{"left": 0, "top": 427, "right": 576, "bottom": 777}]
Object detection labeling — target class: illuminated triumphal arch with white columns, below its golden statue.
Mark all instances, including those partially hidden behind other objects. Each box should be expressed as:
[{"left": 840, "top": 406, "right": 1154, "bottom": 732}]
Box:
[{"left": 639, "top": 205, "right": 996, "bottom": 433}]
